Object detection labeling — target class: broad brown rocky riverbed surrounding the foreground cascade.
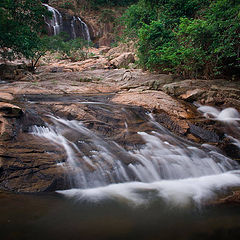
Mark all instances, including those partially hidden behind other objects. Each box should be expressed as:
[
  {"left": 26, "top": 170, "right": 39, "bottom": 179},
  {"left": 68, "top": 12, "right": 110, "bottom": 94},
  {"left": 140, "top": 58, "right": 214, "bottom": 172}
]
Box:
[{"left": 0, "top": 45, "right": 240, "bottom": 201}]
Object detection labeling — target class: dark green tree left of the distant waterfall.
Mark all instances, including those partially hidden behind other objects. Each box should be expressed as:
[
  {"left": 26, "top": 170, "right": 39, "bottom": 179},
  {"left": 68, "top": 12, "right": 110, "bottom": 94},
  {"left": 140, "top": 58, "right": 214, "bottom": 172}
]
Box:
[{"left": 0, "top": 0, "right": 50, "bottom": 67}]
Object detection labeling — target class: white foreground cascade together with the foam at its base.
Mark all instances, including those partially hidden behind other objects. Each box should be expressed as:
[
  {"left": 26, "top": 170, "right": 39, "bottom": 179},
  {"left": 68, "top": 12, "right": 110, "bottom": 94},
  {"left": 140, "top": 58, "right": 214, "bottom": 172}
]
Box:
[{"left": 32, "top": 101, "right": 240, "bottom": 205}]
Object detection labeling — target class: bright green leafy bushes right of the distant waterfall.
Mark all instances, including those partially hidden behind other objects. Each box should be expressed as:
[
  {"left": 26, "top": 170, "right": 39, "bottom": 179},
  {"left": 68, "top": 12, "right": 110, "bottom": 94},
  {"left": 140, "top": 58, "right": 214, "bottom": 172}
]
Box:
[{"left": 124, "top": 0, "right": 240, "bottom": 78}]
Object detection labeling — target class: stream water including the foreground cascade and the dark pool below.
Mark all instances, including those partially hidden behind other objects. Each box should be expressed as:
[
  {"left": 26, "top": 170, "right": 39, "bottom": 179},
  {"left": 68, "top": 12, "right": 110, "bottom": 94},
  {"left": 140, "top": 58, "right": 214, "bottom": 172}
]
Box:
[{"left": 0, "top": 95, "right": 240, "bottom": 240}]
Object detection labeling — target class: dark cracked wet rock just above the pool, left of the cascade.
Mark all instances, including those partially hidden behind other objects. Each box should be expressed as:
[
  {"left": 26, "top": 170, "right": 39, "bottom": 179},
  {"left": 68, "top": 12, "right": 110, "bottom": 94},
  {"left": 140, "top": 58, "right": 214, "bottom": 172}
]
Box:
[{"left": 0, "top": 133, "right": 67, "bottom": 192}]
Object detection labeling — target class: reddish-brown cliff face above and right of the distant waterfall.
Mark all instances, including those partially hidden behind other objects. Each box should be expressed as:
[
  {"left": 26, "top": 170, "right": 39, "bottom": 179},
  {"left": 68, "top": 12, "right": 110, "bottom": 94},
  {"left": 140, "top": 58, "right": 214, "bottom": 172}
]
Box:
[{"left": 46, "top": 0, "right": 124, "bottom": 46}]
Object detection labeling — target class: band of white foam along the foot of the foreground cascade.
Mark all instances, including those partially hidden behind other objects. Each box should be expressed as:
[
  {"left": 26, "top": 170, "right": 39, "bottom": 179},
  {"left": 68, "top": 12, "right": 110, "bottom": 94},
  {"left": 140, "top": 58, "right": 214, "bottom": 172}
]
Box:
[{"left": 58, "top": 171, "right": 240, "bottom": 206}]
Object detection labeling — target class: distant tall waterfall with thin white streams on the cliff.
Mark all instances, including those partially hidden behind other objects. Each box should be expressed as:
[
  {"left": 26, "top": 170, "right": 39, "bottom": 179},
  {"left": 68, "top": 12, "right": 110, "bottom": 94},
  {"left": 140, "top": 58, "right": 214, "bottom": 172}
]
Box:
[{"left": 43, "top": 4, "right": 91, "bottom": 42}]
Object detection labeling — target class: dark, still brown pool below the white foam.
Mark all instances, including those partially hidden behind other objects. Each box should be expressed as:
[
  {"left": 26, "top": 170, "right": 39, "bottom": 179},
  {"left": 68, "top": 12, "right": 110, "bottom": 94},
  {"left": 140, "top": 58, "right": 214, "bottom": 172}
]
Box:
[{"left": 0, "top": 193, "right": 240, "bottom": 240}]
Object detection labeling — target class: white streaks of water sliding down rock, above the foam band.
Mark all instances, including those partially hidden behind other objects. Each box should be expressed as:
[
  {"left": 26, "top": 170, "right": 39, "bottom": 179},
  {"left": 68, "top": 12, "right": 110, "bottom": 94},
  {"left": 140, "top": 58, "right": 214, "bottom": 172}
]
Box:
[{"left": 32, "top": 117, "right": 238, "bottom": 184}]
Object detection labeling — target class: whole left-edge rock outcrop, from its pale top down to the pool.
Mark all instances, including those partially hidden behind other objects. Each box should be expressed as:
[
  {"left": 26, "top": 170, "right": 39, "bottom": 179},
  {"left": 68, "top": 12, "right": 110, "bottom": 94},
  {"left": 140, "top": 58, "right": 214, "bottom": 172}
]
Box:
[{"left": 0, "top": 98, "right": 66, "bottom": 192}]
